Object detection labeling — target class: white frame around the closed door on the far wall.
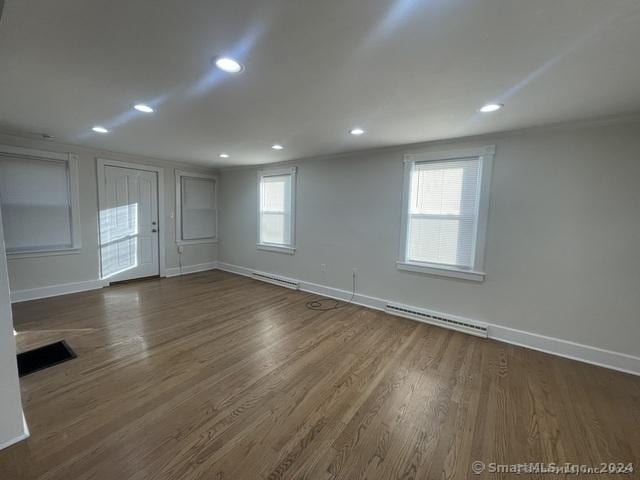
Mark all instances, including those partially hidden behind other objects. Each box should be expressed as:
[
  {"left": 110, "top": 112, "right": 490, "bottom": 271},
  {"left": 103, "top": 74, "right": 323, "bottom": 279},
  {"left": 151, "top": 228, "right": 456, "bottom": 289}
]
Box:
[{"left": 96, "top": 157, "right": 167, "bottom": 279}]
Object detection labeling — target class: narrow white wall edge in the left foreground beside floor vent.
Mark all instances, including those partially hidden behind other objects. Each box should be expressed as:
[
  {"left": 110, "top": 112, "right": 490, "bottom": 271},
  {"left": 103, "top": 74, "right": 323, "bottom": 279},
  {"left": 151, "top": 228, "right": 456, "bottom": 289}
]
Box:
[{"left": 0, "top": 207, "right": 27, "bottom": 448}]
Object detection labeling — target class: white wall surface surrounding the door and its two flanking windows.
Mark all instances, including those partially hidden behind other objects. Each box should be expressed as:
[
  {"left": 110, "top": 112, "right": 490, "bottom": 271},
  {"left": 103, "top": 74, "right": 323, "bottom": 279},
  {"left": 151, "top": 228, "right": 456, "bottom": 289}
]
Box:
[{"left": 0, "top": 134, "right": 217, "bottom": 292}]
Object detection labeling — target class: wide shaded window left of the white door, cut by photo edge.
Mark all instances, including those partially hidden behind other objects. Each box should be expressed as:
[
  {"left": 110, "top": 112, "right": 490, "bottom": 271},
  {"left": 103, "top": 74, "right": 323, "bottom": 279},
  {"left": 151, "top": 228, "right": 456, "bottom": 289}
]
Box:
[{"left": 0, "top": 146, "right": 81, "bottom": 255}]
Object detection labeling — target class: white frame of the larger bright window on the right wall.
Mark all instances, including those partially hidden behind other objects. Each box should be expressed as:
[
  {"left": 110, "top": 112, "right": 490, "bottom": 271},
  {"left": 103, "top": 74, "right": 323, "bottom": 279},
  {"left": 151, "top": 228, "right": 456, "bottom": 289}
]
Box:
[{"left": 396, "top": 145, "right": 495, "bottom": 282}]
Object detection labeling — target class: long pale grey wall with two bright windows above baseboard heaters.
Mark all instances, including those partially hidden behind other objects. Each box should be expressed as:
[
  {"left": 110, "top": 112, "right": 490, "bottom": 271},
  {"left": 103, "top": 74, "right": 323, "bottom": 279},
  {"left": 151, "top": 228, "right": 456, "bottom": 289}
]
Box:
[{"left": 219, "top": 119, "right": 640, "bottom": 361}]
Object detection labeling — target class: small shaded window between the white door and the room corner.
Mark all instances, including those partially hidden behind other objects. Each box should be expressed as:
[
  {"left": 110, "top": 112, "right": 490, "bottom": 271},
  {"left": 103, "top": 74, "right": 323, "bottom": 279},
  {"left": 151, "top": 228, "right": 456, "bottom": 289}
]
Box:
[{"left": 176, "top": 170, "right": 218, "bottom": 245}]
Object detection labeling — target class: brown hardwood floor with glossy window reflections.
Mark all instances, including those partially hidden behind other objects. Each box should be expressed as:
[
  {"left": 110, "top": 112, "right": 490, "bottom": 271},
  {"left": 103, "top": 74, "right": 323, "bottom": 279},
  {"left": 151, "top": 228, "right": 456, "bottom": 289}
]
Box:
[{"left": 0, "top": 271, "right": 640, "bottom": 480}]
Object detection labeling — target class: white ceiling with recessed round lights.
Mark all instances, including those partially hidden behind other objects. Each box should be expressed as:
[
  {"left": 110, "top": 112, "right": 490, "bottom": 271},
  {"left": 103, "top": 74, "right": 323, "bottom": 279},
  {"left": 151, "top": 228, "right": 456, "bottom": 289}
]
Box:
[{"left": 0, "top": 0, "right": 640, "bottom": 165}]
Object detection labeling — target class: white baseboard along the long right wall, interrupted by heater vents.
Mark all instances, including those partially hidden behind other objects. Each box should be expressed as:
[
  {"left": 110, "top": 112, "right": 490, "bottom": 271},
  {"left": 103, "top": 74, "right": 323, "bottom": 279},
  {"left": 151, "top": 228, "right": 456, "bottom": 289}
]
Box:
[{"left": 217, "top": 262, "right": 640, "bottom": 375}]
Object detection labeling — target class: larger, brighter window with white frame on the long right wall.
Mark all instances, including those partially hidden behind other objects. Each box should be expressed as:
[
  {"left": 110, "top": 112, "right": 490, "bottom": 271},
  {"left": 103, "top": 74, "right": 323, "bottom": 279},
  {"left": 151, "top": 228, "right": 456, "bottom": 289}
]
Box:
[{"left": 398, "top": 147, "right": 495, "bottom": 281}]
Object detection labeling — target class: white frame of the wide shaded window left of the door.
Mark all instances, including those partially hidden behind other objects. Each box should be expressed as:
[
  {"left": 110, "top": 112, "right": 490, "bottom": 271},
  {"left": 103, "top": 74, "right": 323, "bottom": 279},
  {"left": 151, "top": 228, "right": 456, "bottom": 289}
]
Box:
[{"left": 0, "top": 145, "right": 82, "bottom": 258}]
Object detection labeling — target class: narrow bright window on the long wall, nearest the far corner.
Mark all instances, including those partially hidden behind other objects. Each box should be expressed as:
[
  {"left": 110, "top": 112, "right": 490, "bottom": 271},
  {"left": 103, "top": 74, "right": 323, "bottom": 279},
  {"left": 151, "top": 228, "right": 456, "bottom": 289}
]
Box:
[{"left": 258, "top": 167, "right": 296, "bottom": 254}]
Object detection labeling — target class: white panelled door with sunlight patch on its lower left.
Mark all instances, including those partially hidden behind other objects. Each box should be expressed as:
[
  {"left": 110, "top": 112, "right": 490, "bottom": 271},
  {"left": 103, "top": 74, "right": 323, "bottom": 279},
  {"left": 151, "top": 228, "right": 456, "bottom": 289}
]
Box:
[{"left": 100, "top": 165, "right": 160, "bottom": 282}]
